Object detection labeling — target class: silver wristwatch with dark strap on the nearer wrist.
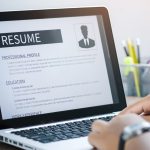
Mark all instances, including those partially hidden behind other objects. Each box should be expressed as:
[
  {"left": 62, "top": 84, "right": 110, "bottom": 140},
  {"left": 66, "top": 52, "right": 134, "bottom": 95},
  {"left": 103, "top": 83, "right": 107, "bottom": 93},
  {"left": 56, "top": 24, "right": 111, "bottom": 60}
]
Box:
[{"left": 119, "top": 121, "right": 150, "bottom": 150}]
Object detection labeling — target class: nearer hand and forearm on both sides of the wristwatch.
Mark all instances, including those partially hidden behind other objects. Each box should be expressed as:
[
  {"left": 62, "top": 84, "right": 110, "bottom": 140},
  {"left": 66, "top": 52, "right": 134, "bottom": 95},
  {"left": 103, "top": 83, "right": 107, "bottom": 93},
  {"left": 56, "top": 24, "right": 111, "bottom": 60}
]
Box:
[{"left": 88, "top": 114, "right": 150, "bottom": 150}]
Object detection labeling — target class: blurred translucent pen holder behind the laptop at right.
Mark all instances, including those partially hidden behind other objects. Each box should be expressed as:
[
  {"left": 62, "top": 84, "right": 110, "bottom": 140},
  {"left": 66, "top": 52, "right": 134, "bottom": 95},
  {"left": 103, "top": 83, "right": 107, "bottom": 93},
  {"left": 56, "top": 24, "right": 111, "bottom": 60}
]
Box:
[{"left": 120, "top": 64, "right": 150, "bottom": 97}]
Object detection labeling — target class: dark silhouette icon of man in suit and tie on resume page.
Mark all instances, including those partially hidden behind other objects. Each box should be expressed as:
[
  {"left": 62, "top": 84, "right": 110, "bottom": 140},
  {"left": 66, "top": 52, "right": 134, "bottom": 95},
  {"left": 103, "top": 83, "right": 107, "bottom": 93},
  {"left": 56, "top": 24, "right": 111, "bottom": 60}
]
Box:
[{"left": 78, "top": 25, "right": 95, "bottom": 48}]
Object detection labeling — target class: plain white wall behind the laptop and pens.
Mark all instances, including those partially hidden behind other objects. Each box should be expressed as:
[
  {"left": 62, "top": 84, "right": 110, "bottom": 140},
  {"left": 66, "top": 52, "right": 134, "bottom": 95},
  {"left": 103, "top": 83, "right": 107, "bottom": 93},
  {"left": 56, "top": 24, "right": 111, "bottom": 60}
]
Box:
[{"left": 0, "top": 0, "right": 150, "bottom": 62}]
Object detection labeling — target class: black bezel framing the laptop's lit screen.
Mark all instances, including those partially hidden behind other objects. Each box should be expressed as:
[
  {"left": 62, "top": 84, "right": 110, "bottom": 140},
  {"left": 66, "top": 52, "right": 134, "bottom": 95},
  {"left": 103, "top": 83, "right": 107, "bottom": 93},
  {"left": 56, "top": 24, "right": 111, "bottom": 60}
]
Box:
[{"left": 0, "top": 7, "right": 126, "bottom": 129}]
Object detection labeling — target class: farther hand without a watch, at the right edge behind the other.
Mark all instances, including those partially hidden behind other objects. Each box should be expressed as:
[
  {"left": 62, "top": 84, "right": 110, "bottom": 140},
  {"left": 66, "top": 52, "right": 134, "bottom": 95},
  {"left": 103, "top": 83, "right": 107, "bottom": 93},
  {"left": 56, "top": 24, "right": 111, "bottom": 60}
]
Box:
[{"left": 119, "top": 95, "right": 150, "bottom": 115}]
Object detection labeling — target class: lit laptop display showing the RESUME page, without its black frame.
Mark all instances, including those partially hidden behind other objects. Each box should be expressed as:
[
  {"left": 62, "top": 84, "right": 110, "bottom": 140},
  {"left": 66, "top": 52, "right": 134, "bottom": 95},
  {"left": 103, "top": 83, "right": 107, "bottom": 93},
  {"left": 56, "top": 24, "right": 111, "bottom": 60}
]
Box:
[{"left": 0, "top": 8, "right": 126, "bottom": 125}]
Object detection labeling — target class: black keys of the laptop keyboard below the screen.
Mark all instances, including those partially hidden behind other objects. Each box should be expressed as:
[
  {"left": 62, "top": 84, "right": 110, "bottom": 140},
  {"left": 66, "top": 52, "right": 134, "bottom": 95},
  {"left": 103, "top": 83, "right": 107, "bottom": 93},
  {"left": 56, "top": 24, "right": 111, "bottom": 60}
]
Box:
[{"left": 11, "top": 116, "right": 114, "bottom": 143}]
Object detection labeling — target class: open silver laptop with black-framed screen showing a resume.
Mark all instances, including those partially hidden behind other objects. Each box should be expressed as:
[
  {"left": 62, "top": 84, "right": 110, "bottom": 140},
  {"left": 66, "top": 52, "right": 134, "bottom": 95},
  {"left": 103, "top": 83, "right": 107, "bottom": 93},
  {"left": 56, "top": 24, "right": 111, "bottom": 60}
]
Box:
[{"left": 0, "top": 7, "right": 126, "bottom": 150}]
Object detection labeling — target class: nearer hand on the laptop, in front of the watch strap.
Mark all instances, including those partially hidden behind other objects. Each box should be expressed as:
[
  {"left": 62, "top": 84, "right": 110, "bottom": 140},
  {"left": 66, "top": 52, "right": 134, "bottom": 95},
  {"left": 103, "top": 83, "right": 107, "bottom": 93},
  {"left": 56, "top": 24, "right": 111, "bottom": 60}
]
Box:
[{"left": 88, "top": 114, "right": 144, "bottom": 150}]
